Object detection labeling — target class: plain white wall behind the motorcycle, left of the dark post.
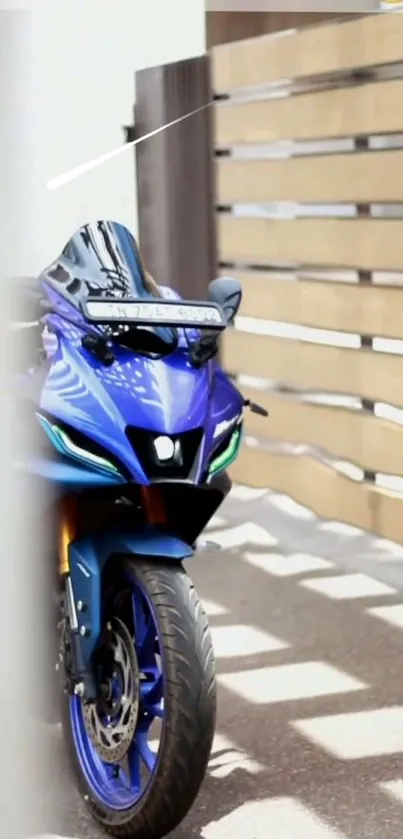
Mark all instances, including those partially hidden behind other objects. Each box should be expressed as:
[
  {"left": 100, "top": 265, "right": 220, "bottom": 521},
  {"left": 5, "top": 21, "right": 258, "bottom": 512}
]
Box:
[{"left": 24, "top": 0, "right": 205, "bottom": 273}]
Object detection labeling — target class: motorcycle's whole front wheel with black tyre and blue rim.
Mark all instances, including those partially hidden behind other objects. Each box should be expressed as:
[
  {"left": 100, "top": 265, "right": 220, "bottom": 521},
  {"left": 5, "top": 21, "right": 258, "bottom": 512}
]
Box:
[{"left": 62, "top": 558, "right": 216, "bottom": 839}]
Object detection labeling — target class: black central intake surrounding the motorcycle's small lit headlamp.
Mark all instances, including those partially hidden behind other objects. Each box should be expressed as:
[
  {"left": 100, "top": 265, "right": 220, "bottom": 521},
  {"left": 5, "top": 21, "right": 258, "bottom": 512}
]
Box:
[{"left": 126, "top": 425, "right": 203, "bottom": 481}]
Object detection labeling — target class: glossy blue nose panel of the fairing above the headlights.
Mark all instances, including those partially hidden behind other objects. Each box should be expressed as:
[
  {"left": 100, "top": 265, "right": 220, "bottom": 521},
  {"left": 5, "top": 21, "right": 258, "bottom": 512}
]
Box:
[{"left": 40, "top": 327, "right": 218, "bottom": 483}]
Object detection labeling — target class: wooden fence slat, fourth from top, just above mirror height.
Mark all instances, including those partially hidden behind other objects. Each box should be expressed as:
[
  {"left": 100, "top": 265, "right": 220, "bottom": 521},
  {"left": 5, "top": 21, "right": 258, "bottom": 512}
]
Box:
[{"left": 217, "top": 213, "right": 403, "bottom": 271}]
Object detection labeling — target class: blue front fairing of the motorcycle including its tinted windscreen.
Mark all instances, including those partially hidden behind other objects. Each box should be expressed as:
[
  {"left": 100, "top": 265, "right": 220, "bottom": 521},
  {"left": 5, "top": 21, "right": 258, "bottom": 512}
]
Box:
[{"left": 29, "top": 213, "right": 246, "bottom": 483}]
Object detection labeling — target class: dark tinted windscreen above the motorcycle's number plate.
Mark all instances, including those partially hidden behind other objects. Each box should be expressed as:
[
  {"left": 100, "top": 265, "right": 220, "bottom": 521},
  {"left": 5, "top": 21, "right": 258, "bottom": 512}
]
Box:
[{"left": 42, "top": 221, "right": 176, "bottom": 347}]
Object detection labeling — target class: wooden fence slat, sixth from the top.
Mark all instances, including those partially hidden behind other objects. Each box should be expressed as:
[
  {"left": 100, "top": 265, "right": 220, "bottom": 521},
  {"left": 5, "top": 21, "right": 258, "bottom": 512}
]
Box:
[{"left": 221, "top": 329, "right": 403, "bottom": 406}]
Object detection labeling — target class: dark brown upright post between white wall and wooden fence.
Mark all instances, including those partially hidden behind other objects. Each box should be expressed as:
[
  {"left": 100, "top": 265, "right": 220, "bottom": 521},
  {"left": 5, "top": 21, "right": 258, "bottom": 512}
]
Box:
[{"left": 135, "top": 55, "right": 217, "bottom": 299}]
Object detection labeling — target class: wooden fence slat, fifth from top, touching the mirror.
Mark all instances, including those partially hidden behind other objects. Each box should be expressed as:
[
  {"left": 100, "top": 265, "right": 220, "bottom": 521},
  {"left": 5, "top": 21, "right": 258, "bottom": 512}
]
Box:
[{"left": 234, "top": 270, "right": 403, "bottom": 339}]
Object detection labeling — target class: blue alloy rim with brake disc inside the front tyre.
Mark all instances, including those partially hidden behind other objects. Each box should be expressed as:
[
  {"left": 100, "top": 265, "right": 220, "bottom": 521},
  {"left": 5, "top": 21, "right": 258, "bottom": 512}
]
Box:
[{"left": 70, "top": 578, "right": 164, "bottom": 810}]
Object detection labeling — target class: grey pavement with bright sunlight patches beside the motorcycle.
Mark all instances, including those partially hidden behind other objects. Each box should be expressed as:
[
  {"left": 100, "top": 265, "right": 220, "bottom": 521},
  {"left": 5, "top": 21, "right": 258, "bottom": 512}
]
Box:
[{"left": 41, "top": 487, "right": 403, "bottom": 839}]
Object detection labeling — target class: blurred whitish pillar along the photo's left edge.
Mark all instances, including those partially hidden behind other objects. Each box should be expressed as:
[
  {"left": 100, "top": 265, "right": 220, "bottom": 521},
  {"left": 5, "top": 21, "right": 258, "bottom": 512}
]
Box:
[{"left": 0, "top": 10, "right": 56, "bottom": 839}]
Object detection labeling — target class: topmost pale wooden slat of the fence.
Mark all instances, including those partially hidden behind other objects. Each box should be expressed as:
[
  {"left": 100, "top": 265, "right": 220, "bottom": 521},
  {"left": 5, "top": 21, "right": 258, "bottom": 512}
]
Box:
[{"left": 212, "top": 15, "right": 403, "bottom": 93}]
